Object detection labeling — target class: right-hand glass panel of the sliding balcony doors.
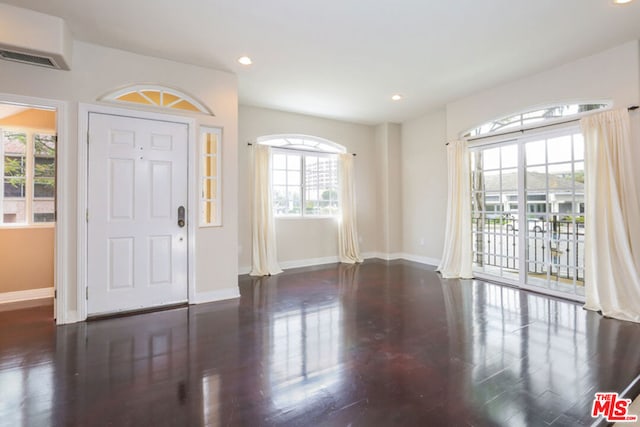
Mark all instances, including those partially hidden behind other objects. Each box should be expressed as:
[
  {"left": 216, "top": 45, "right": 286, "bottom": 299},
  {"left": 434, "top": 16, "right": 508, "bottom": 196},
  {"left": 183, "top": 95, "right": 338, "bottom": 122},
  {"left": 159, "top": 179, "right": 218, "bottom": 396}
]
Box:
[{"left": 524, "top": 133, "right": 584, "bottom": 296}]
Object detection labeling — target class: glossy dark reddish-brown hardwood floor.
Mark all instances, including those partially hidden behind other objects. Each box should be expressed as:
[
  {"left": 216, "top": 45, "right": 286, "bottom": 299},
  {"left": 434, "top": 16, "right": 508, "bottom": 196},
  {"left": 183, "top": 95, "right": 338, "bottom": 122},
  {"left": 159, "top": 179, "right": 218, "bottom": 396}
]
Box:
[{"left": 0, "top": 261, "right": 640, "bottom": 427}]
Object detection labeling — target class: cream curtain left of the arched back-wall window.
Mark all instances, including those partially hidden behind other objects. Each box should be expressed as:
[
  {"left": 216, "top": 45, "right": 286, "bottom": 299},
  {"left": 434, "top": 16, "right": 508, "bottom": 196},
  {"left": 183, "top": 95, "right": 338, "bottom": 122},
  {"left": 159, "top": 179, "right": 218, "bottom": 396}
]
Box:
[{"left": 250, "top": 144, "right": 282, "bottom": 276}]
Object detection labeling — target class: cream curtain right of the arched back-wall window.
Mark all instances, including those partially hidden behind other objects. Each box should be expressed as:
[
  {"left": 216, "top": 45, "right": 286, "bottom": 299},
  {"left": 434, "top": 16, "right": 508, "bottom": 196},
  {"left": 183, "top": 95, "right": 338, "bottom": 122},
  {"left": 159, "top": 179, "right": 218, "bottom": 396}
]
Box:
[{"left": 338, "top": 154, "right": 362, "bottom": 264}]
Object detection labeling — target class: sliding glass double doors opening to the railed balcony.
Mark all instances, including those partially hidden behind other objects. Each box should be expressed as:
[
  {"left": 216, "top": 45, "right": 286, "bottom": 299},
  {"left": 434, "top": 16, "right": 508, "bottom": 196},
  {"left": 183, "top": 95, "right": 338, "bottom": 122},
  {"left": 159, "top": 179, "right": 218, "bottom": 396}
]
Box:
[{"left": 471, "top": 128, "right": 585, "bottom": 300}]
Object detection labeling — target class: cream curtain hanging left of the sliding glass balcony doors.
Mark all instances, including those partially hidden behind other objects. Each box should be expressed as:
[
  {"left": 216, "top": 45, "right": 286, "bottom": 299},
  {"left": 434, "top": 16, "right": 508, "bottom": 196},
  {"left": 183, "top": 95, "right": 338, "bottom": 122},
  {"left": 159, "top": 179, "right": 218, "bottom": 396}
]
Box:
[{"left": 438, "top": 141, "right": 473, "bottom": 279}]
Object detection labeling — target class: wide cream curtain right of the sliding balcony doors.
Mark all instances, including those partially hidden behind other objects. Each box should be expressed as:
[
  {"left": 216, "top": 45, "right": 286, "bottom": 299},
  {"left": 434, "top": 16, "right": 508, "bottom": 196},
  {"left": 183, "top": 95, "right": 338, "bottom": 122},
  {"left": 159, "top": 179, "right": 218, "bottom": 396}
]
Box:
[{"left": 580, "top": 109, "right": 640, "bottom": 322}]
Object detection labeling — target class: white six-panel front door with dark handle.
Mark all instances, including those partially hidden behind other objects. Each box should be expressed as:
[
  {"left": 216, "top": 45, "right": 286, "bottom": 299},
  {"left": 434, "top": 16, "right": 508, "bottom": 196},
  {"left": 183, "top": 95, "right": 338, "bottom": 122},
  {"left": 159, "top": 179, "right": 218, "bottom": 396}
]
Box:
[{"left": 87, "top": 113, "right": 188, "bottom": 315}]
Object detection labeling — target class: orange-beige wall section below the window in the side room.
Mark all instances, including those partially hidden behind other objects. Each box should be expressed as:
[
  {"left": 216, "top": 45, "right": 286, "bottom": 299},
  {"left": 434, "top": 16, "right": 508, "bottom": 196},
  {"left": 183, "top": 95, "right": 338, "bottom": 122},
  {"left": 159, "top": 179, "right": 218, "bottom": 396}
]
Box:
[{"left": 0, "top": 227, "right": 55, "bottom": 293}]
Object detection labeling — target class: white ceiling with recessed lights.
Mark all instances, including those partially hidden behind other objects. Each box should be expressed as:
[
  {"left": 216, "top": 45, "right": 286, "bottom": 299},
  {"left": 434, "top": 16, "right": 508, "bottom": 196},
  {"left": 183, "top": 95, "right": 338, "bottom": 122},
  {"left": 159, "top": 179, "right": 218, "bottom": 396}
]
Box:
[{"left": 4, "top": 0, "right": 640, "bottom": 124}]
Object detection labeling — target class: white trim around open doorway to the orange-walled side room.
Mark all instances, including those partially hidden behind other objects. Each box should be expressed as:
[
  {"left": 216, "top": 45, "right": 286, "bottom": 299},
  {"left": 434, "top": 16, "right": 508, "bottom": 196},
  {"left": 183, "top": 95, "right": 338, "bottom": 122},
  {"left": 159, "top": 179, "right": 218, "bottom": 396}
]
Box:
[{"left": 0, "top": 93, "right": 68, "bottom": 325}]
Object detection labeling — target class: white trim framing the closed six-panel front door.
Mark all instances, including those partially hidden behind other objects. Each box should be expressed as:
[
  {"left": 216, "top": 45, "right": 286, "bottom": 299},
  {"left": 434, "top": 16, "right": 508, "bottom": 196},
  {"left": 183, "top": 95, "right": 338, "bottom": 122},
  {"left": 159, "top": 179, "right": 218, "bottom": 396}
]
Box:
[{"left": 74, "top": 103, "right": 198, "bottom": 321}]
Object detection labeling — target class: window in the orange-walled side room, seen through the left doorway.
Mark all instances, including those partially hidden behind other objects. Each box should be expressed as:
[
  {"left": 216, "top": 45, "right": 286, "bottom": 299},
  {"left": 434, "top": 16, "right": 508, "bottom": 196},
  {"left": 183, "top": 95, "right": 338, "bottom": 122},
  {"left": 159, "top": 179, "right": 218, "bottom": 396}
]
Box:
[{"left": 0, "top": 128, "right": 56, "bottom": 225}]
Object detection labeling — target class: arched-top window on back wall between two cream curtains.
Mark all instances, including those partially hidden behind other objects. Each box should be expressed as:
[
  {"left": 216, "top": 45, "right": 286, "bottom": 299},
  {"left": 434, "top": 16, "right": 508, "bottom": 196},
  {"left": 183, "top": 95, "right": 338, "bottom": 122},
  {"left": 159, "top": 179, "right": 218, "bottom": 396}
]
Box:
[{"left": 257, "top": 135, "right": 347, "bottom": 218}]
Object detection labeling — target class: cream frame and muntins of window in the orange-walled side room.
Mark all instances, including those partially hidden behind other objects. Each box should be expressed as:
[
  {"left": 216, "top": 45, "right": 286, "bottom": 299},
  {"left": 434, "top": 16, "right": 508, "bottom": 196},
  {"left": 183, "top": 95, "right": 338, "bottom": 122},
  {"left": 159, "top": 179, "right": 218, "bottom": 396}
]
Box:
[{"left": 0, "top": 126, "right": 58, "bottom": 229}]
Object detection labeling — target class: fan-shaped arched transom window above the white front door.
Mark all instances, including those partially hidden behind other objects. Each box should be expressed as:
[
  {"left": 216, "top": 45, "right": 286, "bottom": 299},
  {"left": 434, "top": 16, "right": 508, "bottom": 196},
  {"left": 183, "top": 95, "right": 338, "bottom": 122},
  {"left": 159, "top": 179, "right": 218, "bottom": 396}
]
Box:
[{"left": 100, "top": 85, "right": 214, "bottom": 116}]
